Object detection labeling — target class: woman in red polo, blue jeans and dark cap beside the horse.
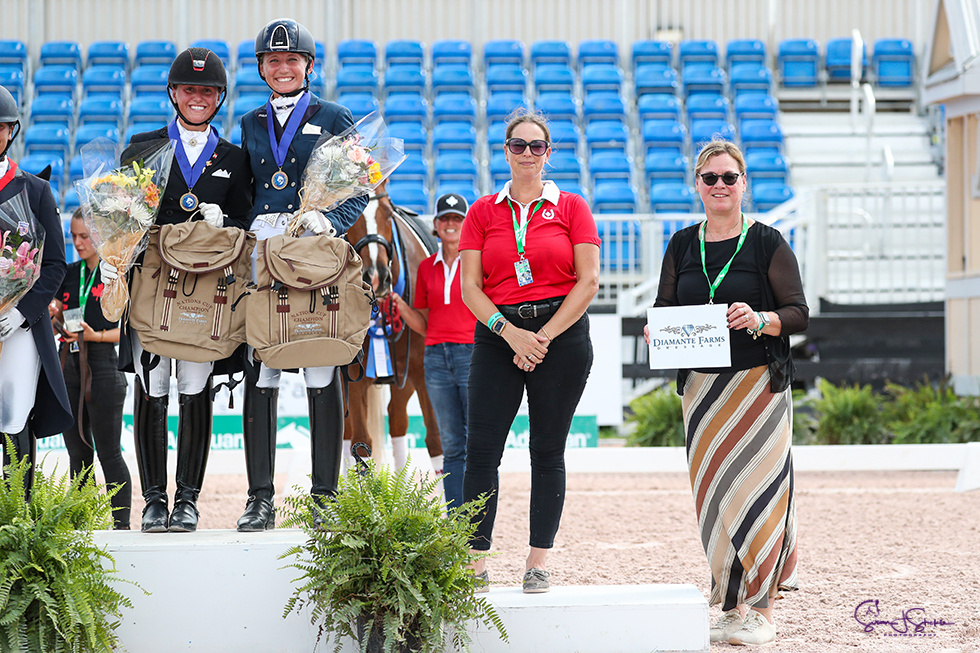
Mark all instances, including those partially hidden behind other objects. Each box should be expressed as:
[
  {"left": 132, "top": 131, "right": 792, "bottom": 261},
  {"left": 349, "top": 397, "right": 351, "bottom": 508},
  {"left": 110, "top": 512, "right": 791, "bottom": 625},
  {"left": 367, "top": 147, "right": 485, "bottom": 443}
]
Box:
[{"left": 394, "top": 193, "right": 476, "bottom": 508}]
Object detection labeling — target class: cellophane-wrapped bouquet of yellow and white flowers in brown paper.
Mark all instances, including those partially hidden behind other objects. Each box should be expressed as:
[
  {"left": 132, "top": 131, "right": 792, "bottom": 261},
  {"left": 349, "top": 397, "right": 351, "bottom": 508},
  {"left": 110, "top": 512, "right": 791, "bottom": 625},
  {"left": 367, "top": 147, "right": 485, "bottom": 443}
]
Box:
[{"left": 75, "top": 141, "right": 175, "bottom": 322}]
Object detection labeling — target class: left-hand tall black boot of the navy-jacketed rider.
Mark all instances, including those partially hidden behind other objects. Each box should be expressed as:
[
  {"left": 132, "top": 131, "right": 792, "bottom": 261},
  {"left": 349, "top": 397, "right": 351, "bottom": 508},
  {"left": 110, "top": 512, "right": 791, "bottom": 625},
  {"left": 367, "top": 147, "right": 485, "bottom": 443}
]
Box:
[{"left": 238, "top": 380, "right": 279, "bottom": 532}]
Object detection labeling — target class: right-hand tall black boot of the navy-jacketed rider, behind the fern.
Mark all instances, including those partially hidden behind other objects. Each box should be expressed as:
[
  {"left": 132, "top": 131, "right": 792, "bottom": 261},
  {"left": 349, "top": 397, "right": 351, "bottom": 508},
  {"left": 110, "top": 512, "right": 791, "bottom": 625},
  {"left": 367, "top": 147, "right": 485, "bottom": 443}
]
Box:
[{"left": 314, "top": 368, "right": 344, "bottom": 525}]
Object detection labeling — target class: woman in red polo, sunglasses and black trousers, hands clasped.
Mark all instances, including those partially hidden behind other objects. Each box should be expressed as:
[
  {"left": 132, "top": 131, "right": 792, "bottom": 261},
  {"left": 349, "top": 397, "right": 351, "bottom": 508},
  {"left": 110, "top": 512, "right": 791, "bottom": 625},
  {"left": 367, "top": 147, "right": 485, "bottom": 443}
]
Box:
[{"left": 459, "top": 112, "right": 599, "bottom": 593}]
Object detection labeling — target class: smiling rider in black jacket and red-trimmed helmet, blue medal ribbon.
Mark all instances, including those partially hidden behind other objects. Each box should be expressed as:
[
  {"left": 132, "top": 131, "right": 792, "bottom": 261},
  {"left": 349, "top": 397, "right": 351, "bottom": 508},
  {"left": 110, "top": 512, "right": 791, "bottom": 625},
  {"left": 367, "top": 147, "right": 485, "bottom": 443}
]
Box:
[{"left": 100, "top": 48, "right": 252, "bottom": 533}]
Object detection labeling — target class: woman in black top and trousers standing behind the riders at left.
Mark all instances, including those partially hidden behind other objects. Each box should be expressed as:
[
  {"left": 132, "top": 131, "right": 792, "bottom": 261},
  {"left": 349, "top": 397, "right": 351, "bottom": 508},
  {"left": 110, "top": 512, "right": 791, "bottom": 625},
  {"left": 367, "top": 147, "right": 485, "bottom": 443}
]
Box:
[{"left": 55, "top": 209, "right": 132, "bottom": 530}]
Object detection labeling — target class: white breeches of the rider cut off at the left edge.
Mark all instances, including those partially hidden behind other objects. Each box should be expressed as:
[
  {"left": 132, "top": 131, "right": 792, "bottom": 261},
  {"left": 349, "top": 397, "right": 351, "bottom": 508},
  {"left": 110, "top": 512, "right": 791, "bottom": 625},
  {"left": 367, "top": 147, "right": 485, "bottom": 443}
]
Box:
[{"left": 0, "top": 327, "right": 41, "bottom": 433}]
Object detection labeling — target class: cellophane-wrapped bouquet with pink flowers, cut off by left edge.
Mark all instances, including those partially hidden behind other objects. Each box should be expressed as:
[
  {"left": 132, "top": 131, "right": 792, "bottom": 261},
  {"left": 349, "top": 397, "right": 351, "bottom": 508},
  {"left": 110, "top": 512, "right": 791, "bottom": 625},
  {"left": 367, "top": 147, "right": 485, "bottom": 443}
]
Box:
[{"left": 0, "top": 188, "right": 44, "bottom": 360}]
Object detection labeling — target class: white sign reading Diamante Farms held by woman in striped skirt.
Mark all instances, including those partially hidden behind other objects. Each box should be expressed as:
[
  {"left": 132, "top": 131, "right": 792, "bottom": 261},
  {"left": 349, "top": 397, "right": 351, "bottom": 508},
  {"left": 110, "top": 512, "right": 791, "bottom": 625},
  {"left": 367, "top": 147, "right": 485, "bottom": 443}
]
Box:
[{"left": 647, "top": 304, "right": 732, "bottom": 370}]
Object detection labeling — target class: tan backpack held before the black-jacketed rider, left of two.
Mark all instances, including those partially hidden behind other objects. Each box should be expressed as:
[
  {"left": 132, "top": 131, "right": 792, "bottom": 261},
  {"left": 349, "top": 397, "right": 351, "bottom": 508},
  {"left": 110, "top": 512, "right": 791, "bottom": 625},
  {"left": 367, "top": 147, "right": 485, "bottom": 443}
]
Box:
[{"left": 129, "top": 221, "right": 255, "bottom": 363}]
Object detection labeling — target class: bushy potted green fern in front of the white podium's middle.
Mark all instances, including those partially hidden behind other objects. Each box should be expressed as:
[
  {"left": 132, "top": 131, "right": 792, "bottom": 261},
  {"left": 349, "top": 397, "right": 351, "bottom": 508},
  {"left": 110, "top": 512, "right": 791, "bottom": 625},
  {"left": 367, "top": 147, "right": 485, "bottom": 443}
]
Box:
[{"left": 281, "top": 461, "right": 507, "bottom": 652}]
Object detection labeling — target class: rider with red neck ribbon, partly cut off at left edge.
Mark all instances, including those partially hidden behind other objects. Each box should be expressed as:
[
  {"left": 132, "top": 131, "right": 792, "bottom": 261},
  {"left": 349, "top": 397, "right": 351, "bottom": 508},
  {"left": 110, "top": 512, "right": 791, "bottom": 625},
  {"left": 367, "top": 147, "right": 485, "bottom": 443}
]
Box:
[{"left": 0, "top": 86, "right": 72, "bottom": 490}]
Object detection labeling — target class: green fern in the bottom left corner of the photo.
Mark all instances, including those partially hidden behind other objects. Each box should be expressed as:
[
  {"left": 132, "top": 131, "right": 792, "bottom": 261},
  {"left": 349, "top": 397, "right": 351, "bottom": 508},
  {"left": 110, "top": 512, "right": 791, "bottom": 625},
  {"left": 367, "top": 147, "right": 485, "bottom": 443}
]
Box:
[{"left": 0, "top": 440, "right": 140, "bottom": 653}]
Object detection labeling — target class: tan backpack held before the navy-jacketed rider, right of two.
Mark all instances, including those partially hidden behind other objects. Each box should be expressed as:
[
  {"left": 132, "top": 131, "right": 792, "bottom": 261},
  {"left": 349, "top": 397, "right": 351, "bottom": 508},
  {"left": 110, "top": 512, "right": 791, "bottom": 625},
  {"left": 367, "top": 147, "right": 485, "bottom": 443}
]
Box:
[{"left": 245, "top": 236, "right": 372, "bottom": 369}]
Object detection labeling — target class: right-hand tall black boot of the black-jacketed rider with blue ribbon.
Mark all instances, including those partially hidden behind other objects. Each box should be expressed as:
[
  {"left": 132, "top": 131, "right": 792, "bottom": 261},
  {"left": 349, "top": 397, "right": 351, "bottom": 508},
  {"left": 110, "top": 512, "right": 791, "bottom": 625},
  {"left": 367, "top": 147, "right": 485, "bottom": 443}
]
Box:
[{"left": 170, "top": 379, "right": 214, "bottom": 533}]
